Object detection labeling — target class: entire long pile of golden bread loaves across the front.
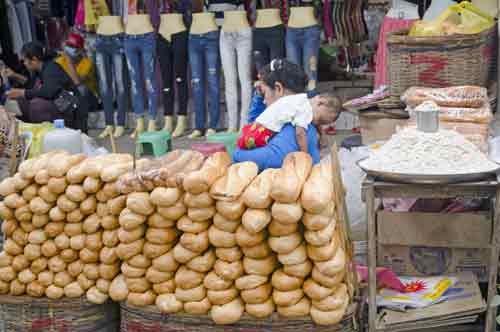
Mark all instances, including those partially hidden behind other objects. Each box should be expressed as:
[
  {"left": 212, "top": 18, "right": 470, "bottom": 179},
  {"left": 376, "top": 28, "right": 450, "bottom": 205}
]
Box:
[{"left": 0, "top": 150, "right": 352, "bottom": 325}]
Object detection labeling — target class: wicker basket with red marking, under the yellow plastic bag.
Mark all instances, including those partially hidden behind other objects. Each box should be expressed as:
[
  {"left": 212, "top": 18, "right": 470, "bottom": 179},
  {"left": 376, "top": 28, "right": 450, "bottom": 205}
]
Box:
[{"left": 379, "top": 25, "right": 498, "bottom": 108}]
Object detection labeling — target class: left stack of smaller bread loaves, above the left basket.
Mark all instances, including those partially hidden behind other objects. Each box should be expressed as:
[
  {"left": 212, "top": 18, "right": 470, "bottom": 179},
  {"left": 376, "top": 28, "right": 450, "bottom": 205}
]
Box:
[{"left": 0, "top": 152, "right": 137, "bottom": 303}]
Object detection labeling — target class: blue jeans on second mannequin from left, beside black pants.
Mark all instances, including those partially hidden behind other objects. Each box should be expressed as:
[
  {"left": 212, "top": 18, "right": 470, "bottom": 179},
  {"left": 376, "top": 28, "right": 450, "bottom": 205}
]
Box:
[{"left": 124, "top": 32, "right": 158, "bottom": 120}]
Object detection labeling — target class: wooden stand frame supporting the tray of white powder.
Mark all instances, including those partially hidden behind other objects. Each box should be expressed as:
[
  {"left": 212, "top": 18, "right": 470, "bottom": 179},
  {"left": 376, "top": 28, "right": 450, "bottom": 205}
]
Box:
[{"left": 362, "top": 177, "right": 500, "bottom": 332}]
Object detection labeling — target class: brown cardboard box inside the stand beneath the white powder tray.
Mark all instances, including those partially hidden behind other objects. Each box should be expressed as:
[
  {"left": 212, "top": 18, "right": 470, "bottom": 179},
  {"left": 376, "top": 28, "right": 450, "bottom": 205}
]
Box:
[{"left": 377, "top": 211, "right": 492, "bottom": 282}]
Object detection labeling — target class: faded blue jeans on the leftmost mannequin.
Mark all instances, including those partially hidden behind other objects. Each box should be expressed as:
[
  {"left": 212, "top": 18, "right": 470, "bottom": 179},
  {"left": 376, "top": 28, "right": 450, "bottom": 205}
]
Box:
[{"left": 95, "top": 34, "right": 127, "bottom": 126}]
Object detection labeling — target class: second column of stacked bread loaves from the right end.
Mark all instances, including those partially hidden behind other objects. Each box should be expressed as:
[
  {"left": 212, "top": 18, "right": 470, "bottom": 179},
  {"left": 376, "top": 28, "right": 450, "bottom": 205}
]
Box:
[{"left": 269, "top": 153, "right": 312, "bottom": 317}]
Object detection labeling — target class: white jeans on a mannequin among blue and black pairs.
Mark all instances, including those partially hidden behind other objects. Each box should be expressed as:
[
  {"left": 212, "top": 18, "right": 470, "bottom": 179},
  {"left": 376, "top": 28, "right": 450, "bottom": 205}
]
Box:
[{"left": 220, "top": 28, "right": 252, "bottom": 129}]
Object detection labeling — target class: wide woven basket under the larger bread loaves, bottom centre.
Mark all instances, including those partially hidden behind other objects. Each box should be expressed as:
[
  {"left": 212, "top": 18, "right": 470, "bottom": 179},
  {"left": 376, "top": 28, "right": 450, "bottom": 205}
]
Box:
[{"left": 120, "top": 303, "right": 357, "bottom": 332}]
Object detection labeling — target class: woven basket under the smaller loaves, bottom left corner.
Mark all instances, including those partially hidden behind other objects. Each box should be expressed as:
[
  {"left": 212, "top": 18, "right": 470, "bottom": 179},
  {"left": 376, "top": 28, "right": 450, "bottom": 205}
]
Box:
[{"left": 0, "top": 295, "right": 120, "bottom": 332}]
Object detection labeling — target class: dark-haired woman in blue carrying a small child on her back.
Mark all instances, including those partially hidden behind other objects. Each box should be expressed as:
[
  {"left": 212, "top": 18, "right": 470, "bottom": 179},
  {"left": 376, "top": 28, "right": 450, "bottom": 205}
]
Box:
[{"left": 233, "top": 60, "right": 320, "bottom": 171}]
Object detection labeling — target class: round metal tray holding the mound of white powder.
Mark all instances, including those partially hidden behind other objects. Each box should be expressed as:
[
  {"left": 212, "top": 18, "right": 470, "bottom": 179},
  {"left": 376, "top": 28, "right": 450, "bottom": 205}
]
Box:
[{"left": 356, "top": 158, "right": 500, "bottom": 184}]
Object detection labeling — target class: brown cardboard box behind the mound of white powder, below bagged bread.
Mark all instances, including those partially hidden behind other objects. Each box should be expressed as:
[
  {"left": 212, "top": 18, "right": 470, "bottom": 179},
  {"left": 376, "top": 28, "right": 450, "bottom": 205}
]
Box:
[{"left": 359, "top": 115, "right": 408, "bottom": 145}]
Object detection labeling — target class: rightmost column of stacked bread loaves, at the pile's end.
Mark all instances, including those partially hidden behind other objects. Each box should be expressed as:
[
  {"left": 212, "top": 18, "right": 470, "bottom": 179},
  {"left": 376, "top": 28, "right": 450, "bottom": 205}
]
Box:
[{"left": 301, "top": 163, "right": 349, "bottom": 325}]
